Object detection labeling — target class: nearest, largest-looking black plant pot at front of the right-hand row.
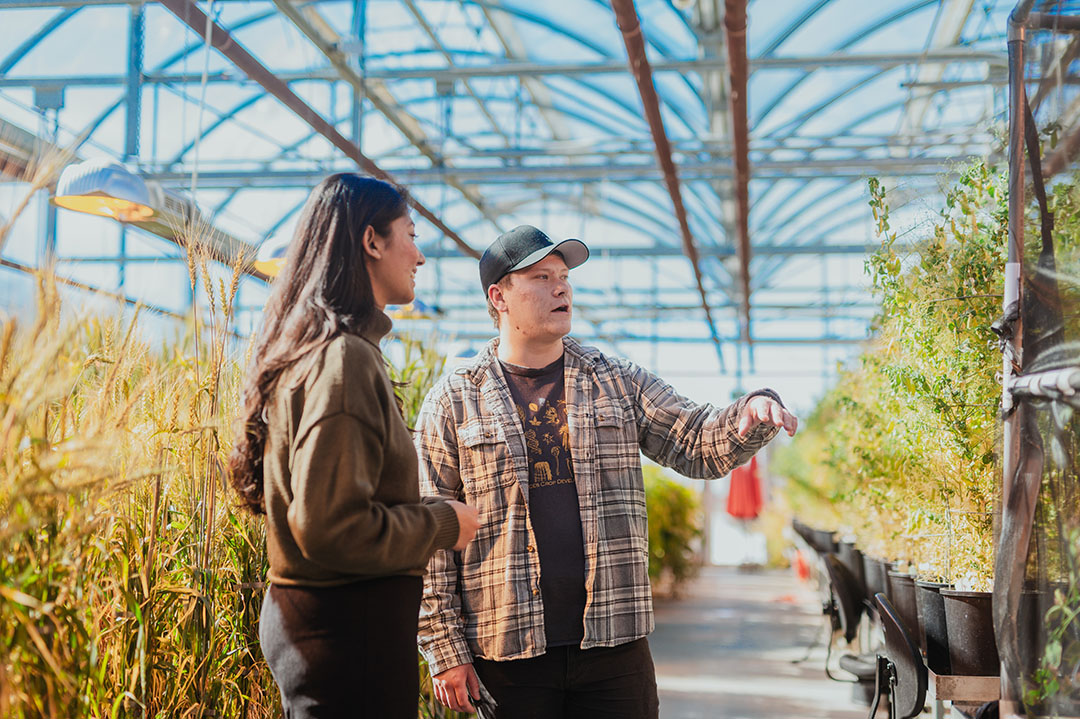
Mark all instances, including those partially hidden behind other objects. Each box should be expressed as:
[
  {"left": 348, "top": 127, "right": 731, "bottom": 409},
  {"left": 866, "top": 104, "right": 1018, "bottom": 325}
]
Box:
[{"left": 941, "top": 589, "right": 1001, "bottom": 677}]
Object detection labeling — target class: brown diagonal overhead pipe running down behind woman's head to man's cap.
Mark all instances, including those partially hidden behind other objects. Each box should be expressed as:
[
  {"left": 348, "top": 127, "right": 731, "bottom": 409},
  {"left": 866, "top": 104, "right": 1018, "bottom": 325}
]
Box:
[{"left": 161, "top": 0, "right": 480, "bottom": 259}]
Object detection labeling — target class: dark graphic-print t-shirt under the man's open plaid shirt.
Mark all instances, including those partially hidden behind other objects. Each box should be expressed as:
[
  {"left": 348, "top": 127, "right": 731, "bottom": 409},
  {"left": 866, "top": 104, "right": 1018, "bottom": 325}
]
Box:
[{"left": 501, "top": 357, "right": 585, "bottom": 647}]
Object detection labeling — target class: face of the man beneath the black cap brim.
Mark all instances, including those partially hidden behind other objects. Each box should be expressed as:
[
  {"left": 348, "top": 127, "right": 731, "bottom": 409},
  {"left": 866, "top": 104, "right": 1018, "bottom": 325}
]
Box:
[{"left": 488, "top": 253, "right": 573, "bottom": 341}]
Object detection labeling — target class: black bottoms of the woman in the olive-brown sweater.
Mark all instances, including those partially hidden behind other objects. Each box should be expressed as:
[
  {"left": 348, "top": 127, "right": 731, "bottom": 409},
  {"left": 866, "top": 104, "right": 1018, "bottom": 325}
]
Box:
[{"left": 259, "top": 576, "right": 423, "bottom": 719}]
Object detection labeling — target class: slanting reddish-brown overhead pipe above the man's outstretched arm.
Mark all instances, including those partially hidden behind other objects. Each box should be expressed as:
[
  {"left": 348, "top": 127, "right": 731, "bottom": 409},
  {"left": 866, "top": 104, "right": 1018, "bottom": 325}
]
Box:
[{"left": 611, "top": 0, "right": 725, "bottom": 371}]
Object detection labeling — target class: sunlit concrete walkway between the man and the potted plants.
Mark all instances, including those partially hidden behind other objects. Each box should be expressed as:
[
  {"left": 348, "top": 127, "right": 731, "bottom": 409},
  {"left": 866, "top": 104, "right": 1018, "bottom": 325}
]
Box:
[{"left": 649, "top": 567, "right": 867, "bottom": 719}]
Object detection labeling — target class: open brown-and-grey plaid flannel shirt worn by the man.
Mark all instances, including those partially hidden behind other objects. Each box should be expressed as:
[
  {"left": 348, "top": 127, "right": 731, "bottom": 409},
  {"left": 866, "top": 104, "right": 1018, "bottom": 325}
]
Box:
[{"left": 415, "top": 338, "right": 779, "bottom": 675}]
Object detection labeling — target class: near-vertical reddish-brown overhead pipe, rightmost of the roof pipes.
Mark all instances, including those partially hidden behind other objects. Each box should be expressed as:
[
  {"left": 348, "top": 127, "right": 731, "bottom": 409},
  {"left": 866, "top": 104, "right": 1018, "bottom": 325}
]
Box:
[{"left": 724, "top": 0, "right": 751, "bottom": 345}]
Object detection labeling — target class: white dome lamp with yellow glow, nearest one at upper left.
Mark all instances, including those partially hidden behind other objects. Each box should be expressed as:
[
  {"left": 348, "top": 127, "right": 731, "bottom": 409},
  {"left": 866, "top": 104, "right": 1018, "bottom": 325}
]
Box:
[{"left": 53, "top": 159, "right": 154, "bottom": 222}]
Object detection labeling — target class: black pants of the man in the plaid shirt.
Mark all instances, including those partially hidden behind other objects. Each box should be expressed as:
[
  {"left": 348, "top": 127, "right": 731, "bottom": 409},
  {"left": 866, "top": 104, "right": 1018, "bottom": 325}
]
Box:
[{"left": 473, "top": 639, "right": 660, "bottom": 719}]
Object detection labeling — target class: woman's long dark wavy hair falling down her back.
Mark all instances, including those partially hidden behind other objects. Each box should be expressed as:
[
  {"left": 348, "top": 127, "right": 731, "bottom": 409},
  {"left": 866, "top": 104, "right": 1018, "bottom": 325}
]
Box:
[{"left": 229, "top": 174, "right": 408, "bottom": 514}]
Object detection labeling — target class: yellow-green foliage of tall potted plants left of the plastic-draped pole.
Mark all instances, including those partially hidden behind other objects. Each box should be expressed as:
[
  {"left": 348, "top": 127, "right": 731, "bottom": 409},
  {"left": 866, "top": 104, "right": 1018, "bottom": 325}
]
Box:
[{"left": 781, "top": 165, "right": 1007, "bottom": 588}]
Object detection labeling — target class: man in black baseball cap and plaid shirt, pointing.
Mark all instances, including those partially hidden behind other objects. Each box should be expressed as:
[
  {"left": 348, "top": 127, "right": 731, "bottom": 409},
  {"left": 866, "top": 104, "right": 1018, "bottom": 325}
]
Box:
[{"left": 416, "top": 226, "right": 798, "bottom": 719}]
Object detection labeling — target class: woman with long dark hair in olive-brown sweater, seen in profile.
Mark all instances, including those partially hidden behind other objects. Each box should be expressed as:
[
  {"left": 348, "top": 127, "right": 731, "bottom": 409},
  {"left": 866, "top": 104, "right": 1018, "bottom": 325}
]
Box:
[{"left": 229, "top": 174, "right": 477, "bottom": 719}]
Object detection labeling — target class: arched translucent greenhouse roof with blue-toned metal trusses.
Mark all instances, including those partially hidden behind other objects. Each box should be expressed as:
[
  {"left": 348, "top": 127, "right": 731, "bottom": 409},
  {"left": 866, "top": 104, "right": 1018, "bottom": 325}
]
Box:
[{"left": 0, "top": 0, "right": 1054, "bottom": 380}]
